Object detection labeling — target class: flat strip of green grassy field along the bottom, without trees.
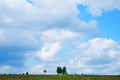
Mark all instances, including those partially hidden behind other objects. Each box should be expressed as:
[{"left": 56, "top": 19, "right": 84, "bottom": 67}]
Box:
[{"left": 0, "top": 75, "right": 120, "bottom": 80}]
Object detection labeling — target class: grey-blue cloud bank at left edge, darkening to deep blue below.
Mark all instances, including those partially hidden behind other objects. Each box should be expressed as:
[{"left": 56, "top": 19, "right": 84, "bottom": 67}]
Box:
[{"left": 0, "top": 28, "right": 42, "bottom": 67}]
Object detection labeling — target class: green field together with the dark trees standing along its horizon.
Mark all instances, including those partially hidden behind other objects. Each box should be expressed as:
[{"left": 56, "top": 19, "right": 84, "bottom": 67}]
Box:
[{"left": 0, "top": 66, "right": 120, "bottom": 80}]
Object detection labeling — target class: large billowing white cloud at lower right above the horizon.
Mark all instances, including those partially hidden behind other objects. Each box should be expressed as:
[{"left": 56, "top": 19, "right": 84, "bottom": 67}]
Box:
[{"left": 70, "top": 38, "right": 120, "bottom": 74}]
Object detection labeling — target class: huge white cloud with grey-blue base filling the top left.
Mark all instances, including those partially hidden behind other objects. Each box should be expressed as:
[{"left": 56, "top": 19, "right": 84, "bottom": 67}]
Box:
[{"left": 0, "top": 0, "right": 98, "bottom": 35}]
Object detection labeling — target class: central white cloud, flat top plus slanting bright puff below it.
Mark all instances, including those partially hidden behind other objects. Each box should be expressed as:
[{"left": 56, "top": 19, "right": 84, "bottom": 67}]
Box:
[{"left": 36, "top": 29, "right": 80, "bottom": 61}]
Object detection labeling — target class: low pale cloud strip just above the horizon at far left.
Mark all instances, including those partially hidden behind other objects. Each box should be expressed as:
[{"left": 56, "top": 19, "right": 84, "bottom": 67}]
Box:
[{"left": 0, "top": 64, "right": 45, "bottom": 74}]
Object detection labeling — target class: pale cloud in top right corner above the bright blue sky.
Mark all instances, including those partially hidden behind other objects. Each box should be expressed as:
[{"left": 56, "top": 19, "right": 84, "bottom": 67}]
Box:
[{"left": 78, "top": 0, "right": 120, "bottom": 16}]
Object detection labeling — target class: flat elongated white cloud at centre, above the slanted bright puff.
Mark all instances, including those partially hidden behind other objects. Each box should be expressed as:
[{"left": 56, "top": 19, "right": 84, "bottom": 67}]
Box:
[{"left": 41, "top": 29, "right": 79, "bottom": 41}]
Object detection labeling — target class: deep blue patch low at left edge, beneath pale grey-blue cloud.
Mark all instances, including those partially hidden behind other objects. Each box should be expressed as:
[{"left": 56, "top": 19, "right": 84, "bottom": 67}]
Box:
[{"left": 0, "top": 49, "right": 25, "bottom": 67}]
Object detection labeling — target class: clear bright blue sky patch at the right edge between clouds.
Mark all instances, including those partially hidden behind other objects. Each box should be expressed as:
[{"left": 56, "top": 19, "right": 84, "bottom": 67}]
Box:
[{"left": 96, "top": 9, "right": 120, "bottom": 41}]
